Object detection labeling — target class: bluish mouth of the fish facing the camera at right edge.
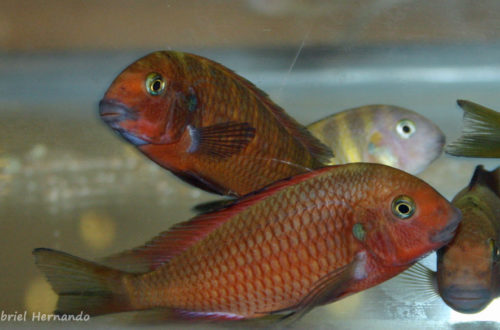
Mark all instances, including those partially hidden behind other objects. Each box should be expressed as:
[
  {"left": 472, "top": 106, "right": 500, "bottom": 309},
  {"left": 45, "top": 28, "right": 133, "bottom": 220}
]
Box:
[{"left": 442, "top": 285, "right": 492, "bottom": 313}]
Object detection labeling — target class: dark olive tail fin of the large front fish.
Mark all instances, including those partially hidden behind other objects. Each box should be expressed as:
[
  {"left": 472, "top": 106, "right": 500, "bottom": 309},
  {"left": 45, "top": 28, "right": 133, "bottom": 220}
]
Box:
[{"left": 33, "top": 248, "right": 135, "bottom": 315}]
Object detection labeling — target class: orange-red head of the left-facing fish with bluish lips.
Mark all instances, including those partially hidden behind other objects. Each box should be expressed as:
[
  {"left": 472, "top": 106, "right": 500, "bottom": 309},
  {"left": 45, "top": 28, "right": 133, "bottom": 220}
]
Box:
[{"left": 99, "top": 52, "right": 197, "bottom": 146}]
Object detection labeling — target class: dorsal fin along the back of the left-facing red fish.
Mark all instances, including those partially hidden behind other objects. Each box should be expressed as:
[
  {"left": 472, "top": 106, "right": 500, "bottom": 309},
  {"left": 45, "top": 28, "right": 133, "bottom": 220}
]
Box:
[{"left": 189, "top": 54, "right": 335, "bottom": 164}]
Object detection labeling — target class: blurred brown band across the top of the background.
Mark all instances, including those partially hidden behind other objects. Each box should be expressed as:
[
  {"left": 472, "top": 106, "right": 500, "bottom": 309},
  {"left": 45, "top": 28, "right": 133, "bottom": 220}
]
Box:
[{"left": 0, "top": 0, "right": 500, "bottom": 52}]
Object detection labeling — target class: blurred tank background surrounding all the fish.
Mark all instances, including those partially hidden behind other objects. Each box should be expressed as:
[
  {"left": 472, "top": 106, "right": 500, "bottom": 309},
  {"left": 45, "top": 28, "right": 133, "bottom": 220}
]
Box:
[{"left": 0, "top": 0, "right": 500, "bottom": 329}]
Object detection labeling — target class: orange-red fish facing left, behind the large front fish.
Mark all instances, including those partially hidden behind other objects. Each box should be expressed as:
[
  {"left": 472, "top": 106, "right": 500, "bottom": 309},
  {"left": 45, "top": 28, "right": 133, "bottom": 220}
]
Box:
[{"left": 100, "top": 51, "right": 332, "bottom": 196}]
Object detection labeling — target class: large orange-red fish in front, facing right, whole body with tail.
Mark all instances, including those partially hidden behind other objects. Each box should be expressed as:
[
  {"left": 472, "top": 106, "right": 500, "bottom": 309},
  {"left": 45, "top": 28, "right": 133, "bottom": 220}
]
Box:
[{"left": 34, "top": 163, "right": 461, "bottom": 319}]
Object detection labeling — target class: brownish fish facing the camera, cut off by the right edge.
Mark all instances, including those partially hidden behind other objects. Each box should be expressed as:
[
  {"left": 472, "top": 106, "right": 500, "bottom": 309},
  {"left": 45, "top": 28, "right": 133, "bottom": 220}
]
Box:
[{"left": 390, "top": 165, "right": 500, "bottom": 313}]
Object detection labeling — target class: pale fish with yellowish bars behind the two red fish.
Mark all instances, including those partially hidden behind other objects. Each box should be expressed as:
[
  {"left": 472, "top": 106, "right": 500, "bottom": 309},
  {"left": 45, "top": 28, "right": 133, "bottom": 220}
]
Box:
[{"left": 307, "top": 104, "right": 445, "bottom": 174}]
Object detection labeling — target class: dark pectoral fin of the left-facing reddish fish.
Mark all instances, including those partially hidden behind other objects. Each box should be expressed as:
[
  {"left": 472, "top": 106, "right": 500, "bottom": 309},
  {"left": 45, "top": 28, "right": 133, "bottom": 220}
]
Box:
[{"left": 188, "top": 122, "right": 255, "bottom": 158}]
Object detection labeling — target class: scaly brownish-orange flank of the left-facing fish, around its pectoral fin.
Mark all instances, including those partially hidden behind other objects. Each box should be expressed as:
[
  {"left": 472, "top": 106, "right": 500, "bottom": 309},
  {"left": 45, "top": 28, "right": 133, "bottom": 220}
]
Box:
[{"left": 185, "top": 53, "right": 319, "bottom": 192}]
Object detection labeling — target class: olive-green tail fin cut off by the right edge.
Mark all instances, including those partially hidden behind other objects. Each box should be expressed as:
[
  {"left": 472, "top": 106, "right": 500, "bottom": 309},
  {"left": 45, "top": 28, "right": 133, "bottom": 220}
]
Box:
[{"left": 445, "top": 100, "right": 500, "bottom": 158}]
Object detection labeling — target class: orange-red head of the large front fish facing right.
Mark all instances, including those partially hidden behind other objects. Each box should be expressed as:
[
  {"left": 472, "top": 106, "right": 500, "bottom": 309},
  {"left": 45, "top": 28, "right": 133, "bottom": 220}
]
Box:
[{"left": 353, "top": 164, "right": 461, "bottom": 266}]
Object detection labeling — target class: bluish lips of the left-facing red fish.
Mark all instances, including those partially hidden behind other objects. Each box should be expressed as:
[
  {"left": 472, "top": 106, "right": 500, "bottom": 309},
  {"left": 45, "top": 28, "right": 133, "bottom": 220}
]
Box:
[{"left": 99, "top": 99, "right": 149, "bottom": 146}]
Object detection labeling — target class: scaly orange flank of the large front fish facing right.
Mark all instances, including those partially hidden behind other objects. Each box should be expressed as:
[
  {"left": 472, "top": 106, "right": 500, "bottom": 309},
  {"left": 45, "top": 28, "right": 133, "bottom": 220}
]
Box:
[{"left": 128, "top": 170, "right": 359, "bottom": 314}]
